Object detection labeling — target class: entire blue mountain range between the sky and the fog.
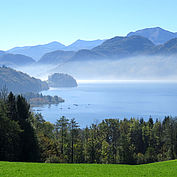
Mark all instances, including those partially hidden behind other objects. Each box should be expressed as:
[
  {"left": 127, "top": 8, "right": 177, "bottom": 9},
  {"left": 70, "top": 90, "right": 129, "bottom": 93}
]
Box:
[{"left": 0, "top": 27, "right": 177, "bottom": 66}]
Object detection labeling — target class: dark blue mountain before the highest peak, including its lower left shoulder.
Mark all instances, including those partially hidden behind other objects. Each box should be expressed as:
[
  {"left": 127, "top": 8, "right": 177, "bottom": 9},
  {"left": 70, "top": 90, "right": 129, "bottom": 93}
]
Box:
[{"left": 71, "top": 36, "right": 154, "bottom": 61}]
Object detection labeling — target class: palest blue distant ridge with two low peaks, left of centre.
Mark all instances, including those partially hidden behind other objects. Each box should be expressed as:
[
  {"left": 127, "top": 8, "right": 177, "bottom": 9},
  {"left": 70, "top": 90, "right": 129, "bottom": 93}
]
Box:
[{"left": 7, "top": 40, "right": 105, "bottom": 61}]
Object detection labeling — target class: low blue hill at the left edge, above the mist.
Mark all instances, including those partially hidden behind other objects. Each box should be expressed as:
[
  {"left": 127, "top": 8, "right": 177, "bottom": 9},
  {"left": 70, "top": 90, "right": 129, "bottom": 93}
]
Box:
[{"left": 0, "top": 52, "right": 35, "bottom": 66}]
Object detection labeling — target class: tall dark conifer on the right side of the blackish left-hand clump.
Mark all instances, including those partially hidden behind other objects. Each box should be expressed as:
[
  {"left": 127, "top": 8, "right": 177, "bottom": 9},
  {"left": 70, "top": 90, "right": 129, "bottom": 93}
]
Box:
[{"left": 16, "top": 95, "right": 39, "bottom": 162}]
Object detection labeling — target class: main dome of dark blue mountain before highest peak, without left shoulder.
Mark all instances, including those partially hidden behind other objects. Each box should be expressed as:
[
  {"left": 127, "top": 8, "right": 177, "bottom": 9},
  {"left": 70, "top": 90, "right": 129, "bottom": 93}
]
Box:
[{"left": 92, "top": 36, "right": 154, "bottom": 58}]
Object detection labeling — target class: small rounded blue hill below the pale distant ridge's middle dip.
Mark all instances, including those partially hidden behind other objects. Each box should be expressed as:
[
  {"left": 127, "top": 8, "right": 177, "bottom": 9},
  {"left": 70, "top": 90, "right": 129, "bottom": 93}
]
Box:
[{"left": 38, "top": 50, "right": 75, "bottom": 64}]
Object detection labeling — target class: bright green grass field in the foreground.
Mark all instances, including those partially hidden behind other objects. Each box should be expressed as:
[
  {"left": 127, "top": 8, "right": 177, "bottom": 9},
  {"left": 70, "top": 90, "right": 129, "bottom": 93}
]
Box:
[{"left": 0, "top": 160, "right": 177, "bottom": 177}]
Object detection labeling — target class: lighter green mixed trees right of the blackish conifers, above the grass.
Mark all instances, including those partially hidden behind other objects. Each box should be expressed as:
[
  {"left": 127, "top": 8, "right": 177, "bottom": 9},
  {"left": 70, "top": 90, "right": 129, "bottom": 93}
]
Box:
[{"left": 35, "top": 115, "right": 177, "bottom": 164}]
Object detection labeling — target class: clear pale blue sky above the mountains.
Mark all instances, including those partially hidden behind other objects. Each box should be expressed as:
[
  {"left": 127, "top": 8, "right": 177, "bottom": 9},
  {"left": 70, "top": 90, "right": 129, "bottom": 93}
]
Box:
[{"left": 0, "top": 0, "right": 177, "bottom": 50}]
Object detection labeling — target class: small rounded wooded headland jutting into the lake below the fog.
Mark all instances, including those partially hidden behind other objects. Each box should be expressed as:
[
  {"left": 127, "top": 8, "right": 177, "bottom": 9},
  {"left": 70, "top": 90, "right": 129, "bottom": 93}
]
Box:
[{"left": 48, "top": 73, "right": 77, "bottom": 87}]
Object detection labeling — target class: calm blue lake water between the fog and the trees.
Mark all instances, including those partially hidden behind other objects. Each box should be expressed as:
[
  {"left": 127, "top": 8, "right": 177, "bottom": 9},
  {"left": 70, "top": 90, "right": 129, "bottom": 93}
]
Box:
[{"left": 34, "top": 82, "right": 177, "bottom": 127}]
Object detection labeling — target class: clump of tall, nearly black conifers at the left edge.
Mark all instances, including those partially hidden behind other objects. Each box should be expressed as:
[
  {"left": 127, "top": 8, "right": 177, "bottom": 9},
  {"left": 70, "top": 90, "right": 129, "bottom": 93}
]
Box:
[{"left": 0, "top": 90, "right": 40, "bottom": 162}]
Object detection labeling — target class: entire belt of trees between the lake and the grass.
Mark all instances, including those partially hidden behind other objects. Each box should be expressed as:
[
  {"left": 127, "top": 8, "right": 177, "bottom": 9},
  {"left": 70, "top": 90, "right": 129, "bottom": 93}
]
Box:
[{"left": 0, "top": 91, "right": 177, "bottom": 164}]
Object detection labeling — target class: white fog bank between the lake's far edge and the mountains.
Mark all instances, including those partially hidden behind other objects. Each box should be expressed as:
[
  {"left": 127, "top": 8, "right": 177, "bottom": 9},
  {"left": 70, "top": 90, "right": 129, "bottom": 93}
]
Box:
[{"left": 16, "top": 56, "right": 177, "bottom": 82}]
